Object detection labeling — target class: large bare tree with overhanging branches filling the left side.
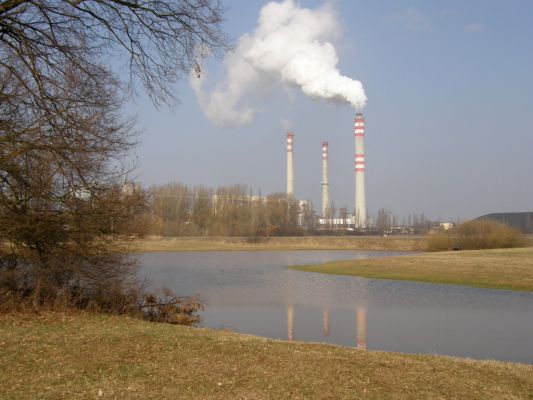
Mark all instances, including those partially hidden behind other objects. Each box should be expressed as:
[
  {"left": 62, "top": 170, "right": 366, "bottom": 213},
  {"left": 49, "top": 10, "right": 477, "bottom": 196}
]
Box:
[{"left": 0, "top": 0, "right": 226, "bottom": 308}]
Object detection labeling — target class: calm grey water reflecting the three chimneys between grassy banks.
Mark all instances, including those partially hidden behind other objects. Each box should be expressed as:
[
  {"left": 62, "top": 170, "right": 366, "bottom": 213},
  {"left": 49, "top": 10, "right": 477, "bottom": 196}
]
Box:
[{"left": 141, "top": 251, "right": 533, "bottom": 363}]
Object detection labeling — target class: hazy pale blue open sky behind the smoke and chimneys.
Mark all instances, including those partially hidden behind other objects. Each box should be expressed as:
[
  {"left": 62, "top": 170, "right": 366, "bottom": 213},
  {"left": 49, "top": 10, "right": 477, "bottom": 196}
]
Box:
[{"left": 128, "top": 0, "right": 533, "bottom": 221}]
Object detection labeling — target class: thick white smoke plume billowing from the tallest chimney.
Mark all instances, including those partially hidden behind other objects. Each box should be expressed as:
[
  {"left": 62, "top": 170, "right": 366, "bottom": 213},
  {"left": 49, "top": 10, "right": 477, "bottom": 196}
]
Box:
[{"left": 191, "top": 0, "right": 367, "bottom": 126}]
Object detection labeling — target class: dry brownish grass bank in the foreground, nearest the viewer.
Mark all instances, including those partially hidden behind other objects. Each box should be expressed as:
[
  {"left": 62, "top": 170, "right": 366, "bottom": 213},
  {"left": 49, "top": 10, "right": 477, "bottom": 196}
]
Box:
[{"left": 0, "top": 314, "right": 533, "bottom": 400}]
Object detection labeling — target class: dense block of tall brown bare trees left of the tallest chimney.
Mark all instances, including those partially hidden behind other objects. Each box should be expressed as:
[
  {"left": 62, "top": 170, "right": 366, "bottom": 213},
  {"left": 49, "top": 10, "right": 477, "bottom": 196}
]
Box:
[{"left": 146, "top": 183, "right": 316, "bottom": 236}]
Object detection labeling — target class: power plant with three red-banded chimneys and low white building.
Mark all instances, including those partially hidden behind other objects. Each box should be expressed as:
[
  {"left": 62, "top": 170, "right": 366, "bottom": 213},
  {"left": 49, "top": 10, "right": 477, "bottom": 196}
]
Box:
[{"left": 287, "top": 112, "right": 368, "bottom": 230}]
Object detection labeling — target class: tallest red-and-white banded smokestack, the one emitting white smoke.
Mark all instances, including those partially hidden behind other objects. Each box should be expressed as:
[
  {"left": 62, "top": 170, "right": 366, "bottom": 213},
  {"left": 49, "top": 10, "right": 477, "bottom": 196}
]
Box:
[{"left": 354, "top": 113, "right": 367, "bottom": 228}]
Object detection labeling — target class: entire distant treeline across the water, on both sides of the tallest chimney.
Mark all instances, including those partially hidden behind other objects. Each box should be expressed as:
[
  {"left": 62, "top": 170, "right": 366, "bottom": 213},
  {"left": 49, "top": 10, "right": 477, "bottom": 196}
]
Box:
[{"left": 144, "top": 183, "right": 439, "bottom": 237}]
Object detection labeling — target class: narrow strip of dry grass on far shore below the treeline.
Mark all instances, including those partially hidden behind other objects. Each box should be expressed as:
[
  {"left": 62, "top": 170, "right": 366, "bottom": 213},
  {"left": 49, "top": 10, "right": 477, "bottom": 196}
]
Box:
[{"left": 135, "top": 236, "right": 426, "bottom": 252}]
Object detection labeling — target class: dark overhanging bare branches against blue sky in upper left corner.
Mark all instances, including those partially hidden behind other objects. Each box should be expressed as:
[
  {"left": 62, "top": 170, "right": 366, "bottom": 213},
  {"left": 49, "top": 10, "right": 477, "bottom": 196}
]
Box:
[{"left": 0, "top": 0, "right": 227, "bottom": 103}]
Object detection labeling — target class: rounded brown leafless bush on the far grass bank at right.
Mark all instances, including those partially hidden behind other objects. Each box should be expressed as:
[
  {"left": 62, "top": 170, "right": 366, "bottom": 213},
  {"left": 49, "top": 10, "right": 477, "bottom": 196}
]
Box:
[{"left": 428, "top": 219, "right": 525, "bottom": 251}]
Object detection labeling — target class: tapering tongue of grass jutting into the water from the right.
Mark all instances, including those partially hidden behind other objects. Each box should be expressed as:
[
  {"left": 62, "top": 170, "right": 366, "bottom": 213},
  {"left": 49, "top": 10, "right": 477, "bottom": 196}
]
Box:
[{"left": 293, "top": 247, "right": 533, "bottom": 291}]
